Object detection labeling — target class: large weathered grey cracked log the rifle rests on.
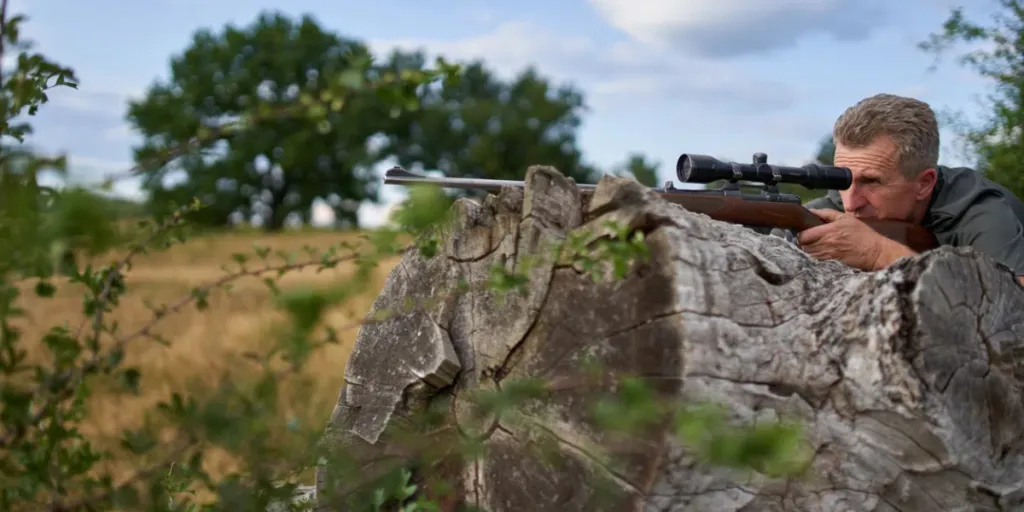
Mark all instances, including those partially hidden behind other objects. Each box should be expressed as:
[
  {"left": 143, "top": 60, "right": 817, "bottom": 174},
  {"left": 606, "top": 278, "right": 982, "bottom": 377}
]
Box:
[{"left": 317, "top": 167, "right": 1024, "bottom": 512}]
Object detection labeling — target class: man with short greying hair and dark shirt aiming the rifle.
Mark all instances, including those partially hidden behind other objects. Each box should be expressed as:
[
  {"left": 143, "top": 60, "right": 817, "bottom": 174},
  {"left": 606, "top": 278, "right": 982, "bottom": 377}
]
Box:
[{"left": 774, "top": 94, "right": 1024, "bottom": 285}]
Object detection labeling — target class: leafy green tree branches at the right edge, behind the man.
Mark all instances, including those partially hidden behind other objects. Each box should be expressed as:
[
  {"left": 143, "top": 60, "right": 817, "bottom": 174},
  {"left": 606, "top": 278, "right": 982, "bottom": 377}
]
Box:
[{"left": 919, "top": 0, "right": 1024, "bottom": 197}]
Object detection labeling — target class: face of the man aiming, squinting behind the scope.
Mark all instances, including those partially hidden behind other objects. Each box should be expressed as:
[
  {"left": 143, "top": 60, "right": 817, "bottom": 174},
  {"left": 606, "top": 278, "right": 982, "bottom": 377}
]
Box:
[{"left": 835, "top": 136, "right": 936, "bottom": 222}]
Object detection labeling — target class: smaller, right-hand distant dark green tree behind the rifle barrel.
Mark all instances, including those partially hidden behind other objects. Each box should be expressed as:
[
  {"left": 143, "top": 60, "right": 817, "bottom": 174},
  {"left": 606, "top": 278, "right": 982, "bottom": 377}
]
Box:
[{"left": 382, "top": 52, "right": 597, "bottom": 182}]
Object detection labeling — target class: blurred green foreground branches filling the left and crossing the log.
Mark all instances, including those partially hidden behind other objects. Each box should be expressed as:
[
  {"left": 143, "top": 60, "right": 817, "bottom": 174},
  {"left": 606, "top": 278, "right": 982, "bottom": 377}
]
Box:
[{"left": 0, "top": 4, "right": 815, "bottom": 512}]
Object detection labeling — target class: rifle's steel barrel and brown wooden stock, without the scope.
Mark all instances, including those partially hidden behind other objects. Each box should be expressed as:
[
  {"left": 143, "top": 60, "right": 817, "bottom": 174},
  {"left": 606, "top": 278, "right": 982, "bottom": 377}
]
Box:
[{"left": 384, "top": 167, "right": 938, "bottom": 253}]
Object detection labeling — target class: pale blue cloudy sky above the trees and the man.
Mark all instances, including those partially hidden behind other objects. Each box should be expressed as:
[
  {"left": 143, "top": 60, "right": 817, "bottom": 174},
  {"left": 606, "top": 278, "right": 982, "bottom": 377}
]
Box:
[{"left": 10, "top": 0, "right": 993, "bottom": 226}]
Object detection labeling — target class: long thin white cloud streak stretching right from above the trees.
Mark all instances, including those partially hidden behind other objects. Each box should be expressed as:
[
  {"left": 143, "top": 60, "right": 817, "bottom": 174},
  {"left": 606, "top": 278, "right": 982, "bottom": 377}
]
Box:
[{"left": 372, "top": 22, "right": 797, "bottom": 113}]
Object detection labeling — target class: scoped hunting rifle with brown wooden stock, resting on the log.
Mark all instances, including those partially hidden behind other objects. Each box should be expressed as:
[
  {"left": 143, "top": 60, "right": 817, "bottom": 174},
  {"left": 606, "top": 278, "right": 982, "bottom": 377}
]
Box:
[{"left": 384, "top": 153, "right": 938, "bottom": 252}]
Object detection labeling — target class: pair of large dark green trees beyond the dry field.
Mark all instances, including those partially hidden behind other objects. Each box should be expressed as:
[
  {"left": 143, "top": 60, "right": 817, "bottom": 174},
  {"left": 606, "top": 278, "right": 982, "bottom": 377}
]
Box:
[{"left": 122, "top": 11, "right": 610, "bottom": 230}]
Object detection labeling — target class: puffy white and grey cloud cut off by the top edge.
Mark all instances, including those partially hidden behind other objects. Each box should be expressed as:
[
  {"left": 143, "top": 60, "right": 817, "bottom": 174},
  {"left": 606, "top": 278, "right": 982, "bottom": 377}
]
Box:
[{"left": 589, "top": 0, "right": 889, "bottom": 57}]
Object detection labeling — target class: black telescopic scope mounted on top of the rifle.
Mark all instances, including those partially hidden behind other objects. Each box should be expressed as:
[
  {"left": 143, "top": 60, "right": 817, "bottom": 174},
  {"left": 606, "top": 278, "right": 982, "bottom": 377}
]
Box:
[{"left": 676, "top": 153, "right": 853, "bottom": 190}]
